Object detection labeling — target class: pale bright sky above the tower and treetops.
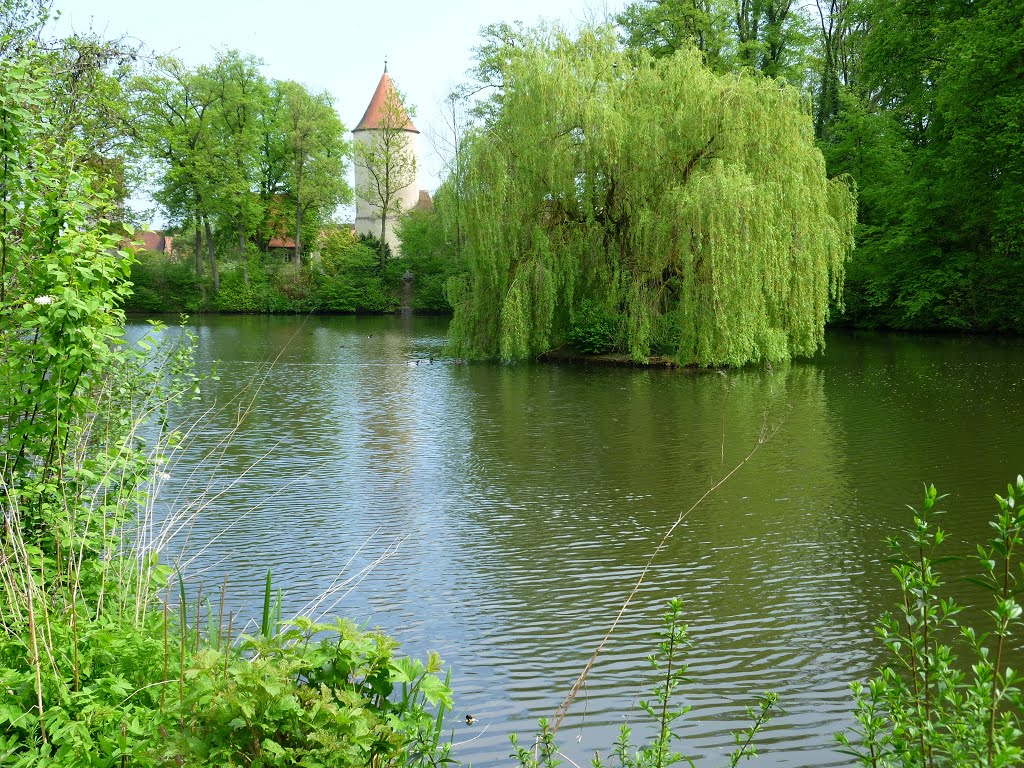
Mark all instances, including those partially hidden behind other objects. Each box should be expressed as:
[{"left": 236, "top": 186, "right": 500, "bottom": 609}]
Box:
[{"left": 53, "top": 0, "right": 627, "bottom": 219}]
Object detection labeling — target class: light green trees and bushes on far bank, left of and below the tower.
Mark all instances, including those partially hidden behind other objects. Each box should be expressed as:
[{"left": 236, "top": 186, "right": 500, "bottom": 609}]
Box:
[{"left": 122, "top": 38, "right": 468, "bottom": 312}]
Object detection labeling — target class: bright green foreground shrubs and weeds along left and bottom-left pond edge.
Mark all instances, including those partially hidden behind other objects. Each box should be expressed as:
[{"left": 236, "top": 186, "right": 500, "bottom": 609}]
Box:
[{"left": 0, "top": 27, "right": 451, "bottom": 768}]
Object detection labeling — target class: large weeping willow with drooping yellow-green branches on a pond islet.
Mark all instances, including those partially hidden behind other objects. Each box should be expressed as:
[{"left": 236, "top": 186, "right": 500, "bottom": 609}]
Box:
[{"left": 451, "top": 29, "right": 856, "bottom": 366}]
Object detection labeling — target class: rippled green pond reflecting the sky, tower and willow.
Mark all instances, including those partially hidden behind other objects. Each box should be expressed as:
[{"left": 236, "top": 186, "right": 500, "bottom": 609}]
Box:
[{"left": 131, "top": 316, "right": 1024, "bottom": 766}]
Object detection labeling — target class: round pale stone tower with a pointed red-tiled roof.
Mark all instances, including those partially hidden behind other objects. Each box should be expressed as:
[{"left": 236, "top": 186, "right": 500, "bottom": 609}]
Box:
[{"left": 352, "top": 63, "right": 420, "bottom": 253}]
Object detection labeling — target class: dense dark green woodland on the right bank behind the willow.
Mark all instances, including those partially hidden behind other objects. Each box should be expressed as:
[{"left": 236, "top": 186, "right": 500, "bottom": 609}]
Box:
[{"left": 617, "top": 0, "right": 1024, "bottom": 333}]
